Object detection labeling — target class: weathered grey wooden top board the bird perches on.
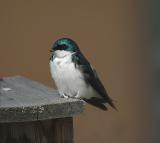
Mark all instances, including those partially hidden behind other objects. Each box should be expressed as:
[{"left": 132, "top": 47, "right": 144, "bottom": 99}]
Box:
[{"left": 0, "top": 76, "right": 83, "bottom": 123}]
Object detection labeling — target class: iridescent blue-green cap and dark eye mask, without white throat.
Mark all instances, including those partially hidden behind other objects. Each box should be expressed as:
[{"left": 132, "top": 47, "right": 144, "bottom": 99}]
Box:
[{"left": 51, "top": 38, "right": 79, "bottom": 52}]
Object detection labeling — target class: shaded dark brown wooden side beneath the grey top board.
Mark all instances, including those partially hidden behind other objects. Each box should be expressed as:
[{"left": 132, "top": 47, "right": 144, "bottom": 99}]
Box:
[{"left": 0, "top": 117, "right": 73, "bottom": 143}]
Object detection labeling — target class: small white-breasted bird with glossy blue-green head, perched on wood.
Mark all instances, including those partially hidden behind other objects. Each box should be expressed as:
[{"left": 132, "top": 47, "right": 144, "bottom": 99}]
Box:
[{"left": 49, "top": 38, "right": 117, "bottom": 111}]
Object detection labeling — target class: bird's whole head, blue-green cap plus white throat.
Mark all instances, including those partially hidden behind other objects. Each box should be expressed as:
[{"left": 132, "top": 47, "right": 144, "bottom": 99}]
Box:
[{"left": 50, "top": 38, "right": 79, "bottom": 57}]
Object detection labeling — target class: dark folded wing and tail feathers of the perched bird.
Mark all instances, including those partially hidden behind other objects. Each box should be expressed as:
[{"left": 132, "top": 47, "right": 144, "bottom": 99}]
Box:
[{"left": 72, "top": 52, "right": 117, "bottom": 110}]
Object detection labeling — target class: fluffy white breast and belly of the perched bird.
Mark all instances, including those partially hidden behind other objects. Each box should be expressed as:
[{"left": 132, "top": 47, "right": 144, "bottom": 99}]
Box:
[{"left": 50, "top": 51, "right": 97, "bottom": 98}]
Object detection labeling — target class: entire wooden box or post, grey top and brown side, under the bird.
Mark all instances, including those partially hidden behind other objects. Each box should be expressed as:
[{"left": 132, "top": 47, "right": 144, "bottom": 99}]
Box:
[{"left": 0, "top": 77, "right": 83, "bottom": 143}]
